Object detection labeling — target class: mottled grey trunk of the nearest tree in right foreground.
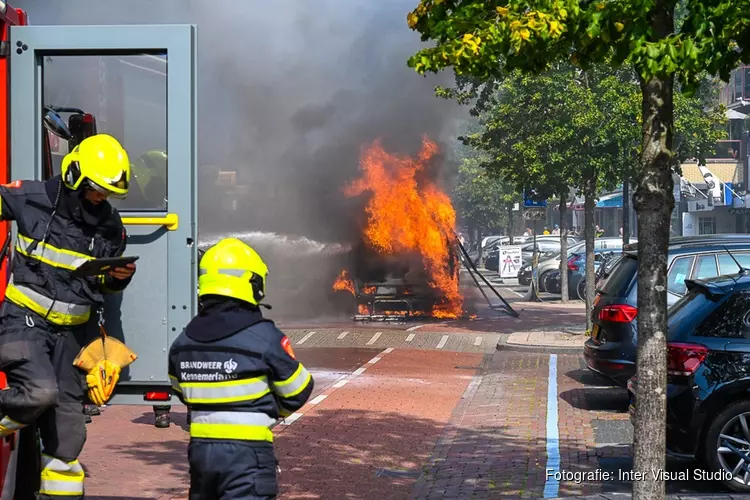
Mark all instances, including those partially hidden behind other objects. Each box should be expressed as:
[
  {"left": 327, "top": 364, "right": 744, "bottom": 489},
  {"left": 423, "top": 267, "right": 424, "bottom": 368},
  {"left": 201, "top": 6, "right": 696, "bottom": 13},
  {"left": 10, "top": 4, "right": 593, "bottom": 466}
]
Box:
[{"left": 633, "top": 62, "right": 674, "bottom": 500}]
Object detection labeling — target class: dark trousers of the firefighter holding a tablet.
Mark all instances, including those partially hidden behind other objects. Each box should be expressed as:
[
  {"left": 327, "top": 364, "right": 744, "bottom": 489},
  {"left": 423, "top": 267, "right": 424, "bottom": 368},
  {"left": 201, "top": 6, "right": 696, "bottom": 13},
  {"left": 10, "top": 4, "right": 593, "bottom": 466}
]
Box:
[{"left": 0, "top": 301, "right": 86, "bottom": 500}]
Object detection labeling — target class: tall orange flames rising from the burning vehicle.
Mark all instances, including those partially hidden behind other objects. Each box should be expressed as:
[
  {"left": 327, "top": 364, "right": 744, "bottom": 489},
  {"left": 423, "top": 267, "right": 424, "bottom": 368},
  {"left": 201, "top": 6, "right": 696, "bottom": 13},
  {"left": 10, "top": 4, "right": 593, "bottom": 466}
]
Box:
[{"left": 344, "top": 136, "right": 463, "bottom": 318}]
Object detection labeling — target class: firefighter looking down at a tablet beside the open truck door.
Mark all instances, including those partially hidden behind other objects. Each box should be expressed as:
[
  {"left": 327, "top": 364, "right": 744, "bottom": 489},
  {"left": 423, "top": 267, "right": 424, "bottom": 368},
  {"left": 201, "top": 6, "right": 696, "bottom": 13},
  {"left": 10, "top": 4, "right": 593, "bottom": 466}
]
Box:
[{"left": 0, "top": 134, "right": 135, "bottom": 499}]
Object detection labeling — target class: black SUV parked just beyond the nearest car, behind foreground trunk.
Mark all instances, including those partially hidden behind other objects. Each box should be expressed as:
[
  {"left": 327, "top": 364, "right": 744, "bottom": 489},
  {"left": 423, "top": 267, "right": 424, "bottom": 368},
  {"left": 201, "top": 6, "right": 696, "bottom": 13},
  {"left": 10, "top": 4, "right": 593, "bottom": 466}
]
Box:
[{"left": 583, "top": 234, "right": 750, "bottom": 387}]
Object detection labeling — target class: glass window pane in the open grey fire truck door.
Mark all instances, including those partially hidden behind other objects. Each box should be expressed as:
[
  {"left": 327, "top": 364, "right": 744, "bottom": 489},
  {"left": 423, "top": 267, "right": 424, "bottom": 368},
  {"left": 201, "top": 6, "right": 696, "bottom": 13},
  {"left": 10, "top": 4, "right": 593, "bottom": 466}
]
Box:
[{"left": 43, "top": 54, "right": 167, "bottom": 211}]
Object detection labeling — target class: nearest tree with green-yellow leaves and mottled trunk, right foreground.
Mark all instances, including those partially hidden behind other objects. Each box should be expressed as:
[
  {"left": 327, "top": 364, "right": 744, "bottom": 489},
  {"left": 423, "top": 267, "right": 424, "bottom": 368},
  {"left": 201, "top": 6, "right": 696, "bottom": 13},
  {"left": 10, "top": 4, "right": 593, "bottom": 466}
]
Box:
[{"left": 407, "top": 0, "right": 750, "bottom": 499}]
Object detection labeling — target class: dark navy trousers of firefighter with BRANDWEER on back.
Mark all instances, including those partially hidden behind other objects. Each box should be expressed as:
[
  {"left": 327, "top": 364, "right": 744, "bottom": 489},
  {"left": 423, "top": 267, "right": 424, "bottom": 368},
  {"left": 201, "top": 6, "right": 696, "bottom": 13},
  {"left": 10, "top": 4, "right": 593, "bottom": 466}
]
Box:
[{"left": 188, "top": 438, "right": 278, "bottom": 500}]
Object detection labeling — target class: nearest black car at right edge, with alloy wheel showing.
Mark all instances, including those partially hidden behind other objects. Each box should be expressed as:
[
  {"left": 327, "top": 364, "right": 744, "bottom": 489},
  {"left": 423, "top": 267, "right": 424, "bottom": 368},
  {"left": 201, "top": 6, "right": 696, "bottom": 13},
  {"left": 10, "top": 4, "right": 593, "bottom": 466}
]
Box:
[{"left": 628, "top": 272, "right": 750, "bottom": 493}]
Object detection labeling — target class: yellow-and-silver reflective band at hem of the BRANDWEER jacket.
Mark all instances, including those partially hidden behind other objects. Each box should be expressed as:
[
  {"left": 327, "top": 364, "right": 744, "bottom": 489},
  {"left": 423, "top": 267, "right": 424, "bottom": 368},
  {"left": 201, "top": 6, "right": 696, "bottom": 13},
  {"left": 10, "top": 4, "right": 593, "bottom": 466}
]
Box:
[{"left": 190, "top": 411, "right": 274, "bottom": 442}]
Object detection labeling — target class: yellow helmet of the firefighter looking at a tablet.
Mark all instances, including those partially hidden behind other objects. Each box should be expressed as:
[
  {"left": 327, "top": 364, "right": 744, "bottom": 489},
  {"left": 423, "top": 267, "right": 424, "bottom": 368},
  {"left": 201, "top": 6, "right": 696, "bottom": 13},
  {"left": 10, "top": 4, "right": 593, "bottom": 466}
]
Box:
[{"left": 60, "top": 134, "right": 130, "bottom": 198}]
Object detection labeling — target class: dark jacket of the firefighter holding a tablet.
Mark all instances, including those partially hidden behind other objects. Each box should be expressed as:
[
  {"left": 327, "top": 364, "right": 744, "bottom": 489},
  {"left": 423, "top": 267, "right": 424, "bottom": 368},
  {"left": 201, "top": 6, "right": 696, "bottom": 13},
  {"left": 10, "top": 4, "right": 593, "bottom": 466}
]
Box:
[{"left": 0, "top": 175, "right": 131, "bottom": 326}]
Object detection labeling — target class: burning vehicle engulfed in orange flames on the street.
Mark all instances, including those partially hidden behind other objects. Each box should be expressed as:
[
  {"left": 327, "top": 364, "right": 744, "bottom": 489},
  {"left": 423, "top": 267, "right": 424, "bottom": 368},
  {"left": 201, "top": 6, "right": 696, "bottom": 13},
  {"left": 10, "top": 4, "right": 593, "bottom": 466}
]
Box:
[{"left": 333, "top": 137, "right": 463, "bottom": 321}]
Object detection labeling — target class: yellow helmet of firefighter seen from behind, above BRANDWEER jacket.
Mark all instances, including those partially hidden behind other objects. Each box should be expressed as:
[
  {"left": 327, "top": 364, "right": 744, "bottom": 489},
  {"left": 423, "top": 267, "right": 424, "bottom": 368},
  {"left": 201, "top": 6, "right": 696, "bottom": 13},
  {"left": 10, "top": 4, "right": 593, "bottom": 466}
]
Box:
[{"left": 198, "top": 238, "right": 268, "bottom": 305}]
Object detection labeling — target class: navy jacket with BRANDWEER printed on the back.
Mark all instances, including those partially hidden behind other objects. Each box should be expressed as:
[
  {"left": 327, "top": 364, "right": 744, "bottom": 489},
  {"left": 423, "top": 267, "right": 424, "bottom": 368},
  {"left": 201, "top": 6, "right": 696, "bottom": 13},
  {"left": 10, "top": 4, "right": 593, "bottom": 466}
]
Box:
[{"left": 169, "top": 299, "right": 314, "bottom": 442}]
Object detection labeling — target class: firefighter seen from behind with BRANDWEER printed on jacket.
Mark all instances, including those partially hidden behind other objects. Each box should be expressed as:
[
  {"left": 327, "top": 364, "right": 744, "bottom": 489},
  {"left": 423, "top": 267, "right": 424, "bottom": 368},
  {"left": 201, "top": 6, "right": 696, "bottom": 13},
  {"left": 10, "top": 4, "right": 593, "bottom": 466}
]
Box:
[{"left": 169, "top": 238, "right": 314, "bottom": 500}]
